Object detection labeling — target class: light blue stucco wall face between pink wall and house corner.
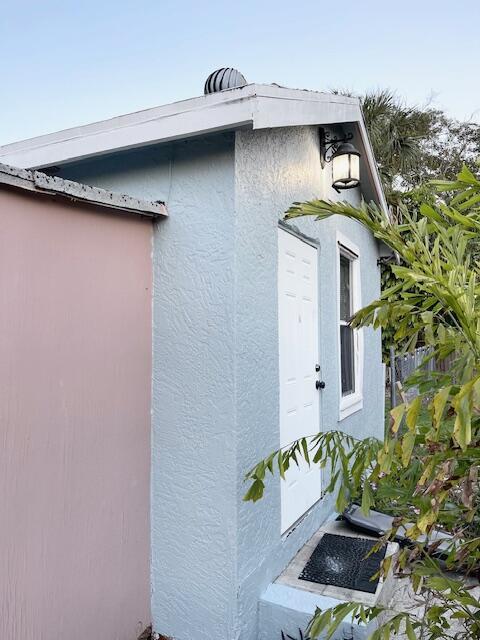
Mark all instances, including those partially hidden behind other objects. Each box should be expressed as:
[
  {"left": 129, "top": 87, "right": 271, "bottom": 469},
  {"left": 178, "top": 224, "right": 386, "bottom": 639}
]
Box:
[{"left": 55, "top": 134, "right": 238, "bottom": 640}]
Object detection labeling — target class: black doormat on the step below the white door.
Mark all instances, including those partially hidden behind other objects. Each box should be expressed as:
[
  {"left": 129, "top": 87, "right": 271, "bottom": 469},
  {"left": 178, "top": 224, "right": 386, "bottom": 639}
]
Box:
[{"left": 298, "top": 533, "right": 387, "bottom": 593}]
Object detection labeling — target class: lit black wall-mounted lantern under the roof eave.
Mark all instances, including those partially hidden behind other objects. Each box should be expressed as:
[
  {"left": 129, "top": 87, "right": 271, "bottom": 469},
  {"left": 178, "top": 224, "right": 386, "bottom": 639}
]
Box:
[{"left": 320, "top": 127, "right": 360, "bottom": 191}]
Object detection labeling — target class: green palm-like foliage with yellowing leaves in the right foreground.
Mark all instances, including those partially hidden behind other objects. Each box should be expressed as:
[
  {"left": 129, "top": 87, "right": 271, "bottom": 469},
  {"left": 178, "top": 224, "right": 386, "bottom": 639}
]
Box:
[{"left": 245, "top": 167, "right": 480, "bottom": 640}]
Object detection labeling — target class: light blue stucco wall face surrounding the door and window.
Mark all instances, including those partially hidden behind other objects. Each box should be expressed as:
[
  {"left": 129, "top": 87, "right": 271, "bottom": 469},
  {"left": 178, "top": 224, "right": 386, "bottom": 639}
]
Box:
[{"left": 235, "top": 127, "right": 383, "bottom": 639}]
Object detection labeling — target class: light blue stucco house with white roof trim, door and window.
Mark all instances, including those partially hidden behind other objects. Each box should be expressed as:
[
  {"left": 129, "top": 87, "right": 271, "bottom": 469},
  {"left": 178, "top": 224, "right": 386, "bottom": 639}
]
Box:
[{"left": 0, "top": 76, "right": 385, "bottom": 640}]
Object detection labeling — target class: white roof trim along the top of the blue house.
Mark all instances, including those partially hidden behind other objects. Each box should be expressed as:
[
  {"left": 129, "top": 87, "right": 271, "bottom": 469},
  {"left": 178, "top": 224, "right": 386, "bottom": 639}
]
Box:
[{"left": 0, "top": 84, "right": 386, "bottom": 207}]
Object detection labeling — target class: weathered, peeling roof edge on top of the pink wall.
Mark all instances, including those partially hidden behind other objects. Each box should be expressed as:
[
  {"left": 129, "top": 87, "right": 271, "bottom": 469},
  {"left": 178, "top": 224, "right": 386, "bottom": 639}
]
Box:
[{"left": 0, "top": 163, "right": 168, "bottom": 219}]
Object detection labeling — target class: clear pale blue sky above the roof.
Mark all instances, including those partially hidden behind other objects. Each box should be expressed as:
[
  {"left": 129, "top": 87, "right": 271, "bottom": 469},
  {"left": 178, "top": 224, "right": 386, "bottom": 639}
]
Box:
[{"left": 0, "top": 0, "right": 480, "bottom": 144}]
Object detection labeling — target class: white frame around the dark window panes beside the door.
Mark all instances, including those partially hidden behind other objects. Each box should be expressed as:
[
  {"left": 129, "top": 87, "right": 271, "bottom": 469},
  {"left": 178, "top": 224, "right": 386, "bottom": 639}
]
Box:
[{"left": 335, "top": 231, "right": 364, "bottom": 422}]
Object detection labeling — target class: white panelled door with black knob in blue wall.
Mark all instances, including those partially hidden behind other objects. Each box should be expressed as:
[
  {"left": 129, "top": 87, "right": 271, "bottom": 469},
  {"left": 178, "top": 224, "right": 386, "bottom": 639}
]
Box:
[{"left": 278, "top": 229, "right": 321, "bottom": 533}]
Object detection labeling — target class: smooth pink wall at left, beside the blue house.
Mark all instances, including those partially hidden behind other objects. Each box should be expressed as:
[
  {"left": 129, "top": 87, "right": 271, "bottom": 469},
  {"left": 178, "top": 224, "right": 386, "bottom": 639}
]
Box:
[{"left": 0, "top": 189, "right": 152, "bottom": 640}]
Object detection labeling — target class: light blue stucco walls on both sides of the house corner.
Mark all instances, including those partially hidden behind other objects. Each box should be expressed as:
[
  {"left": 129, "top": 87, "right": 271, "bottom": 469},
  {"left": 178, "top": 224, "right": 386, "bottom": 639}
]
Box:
[{"left": 56, "top": 127, "right": 383, "bottom": 640}]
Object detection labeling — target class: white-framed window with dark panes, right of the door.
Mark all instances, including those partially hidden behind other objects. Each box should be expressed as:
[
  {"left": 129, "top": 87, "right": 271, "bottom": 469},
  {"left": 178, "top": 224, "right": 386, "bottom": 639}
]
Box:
[{"left": 337, "top": 234, "right": 363, "bottom": 420}]
